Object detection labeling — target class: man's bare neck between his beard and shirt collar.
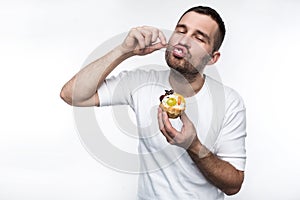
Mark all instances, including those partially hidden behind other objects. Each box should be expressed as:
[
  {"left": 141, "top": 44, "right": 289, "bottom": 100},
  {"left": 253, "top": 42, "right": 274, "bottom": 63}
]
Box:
[{"left": 169, "top": 69, "right": 205, "bottom": 97}]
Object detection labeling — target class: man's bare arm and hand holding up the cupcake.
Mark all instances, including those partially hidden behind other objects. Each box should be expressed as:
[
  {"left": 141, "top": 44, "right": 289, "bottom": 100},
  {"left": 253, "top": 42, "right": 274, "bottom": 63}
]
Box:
[{"left": 158, "top": 108, "right": 244, "bottom": 195}]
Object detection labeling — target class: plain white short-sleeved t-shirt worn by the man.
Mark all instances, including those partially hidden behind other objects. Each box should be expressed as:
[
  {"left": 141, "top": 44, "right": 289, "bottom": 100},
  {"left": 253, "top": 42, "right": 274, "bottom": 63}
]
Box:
[{"left": 98, "top": 70, "right": 246, "bottom": 200}]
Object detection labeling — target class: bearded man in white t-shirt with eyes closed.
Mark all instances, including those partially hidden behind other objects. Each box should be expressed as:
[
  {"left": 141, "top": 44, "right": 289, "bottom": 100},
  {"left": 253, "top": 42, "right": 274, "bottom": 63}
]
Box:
[{"left": 61, "top": 6, "right": 246, "bottom": 200}]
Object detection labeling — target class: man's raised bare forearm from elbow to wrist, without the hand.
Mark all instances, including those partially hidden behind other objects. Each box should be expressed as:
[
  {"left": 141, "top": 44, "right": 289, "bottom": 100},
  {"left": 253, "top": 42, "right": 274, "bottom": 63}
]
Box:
[{"left": 61, "top": 46, "right": 132, "bottom": 106}]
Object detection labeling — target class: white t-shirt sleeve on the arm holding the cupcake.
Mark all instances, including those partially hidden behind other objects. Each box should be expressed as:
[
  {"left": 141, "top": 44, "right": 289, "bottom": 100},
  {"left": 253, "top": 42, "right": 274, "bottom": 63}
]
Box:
[{"left": 216, "top": 91, "right": 247, "bottom": 171}]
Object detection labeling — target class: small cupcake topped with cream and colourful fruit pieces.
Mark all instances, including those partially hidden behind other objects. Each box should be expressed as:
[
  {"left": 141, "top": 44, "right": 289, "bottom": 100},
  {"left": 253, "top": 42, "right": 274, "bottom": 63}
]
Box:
[{"left": 159, "top": 90, "right": 186, "bottom": 119}]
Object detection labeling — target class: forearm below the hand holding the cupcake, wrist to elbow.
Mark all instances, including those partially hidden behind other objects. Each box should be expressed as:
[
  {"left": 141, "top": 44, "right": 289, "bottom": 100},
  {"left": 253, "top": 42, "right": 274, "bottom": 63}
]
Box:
[{"left": 187, "top": 144, "right": 244, "bottom": 195}]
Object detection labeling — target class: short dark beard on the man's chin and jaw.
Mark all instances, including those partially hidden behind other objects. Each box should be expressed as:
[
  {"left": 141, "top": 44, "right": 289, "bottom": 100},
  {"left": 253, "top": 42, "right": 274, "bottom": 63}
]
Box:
[{"left": 165, "top": 50, "right": 207, "bottom": 83}]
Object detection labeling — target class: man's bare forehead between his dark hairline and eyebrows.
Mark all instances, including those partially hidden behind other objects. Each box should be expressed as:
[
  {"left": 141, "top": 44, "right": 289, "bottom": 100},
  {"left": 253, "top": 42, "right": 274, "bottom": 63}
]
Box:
[{"left": 178, "top": 11, "right": 218, "bottom": 37}]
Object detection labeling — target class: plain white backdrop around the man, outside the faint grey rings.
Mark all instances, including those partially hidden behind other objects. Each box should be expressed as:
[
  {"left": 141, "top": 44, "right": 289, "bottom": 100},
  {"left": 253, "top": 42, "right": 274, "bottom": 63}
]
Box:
[{"left": 0, "top": 0, "right": 300, "bottom": 200}]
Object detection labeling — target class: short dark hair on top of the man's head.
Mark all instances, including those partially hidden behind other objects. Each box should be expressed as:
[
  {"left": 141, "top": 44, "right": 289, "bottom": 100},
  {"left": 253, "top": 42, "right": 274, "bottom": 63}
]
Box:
[{"left": 178, "top": 6, "right": 226, "bottom": 51}]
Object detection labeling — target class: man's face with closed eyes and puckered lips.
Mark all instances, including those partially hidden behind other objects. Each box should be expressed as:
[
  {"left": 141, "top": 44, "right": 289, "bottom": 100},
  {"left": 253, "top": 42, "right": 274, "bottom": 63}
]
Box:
[{"left": 165, "top": 11, "right": 219, "bottom": 76}]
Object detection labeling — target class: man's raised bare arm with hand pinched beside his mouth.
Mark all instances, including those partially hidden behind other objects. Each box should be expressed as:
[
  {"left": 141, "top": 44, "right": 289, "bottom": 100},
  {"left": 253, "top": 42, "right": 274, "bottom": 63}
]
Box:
[{"left": 60, "top": 27, "right": 166, "bottom": 107}]
